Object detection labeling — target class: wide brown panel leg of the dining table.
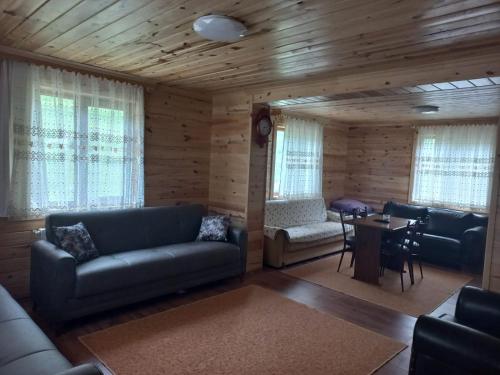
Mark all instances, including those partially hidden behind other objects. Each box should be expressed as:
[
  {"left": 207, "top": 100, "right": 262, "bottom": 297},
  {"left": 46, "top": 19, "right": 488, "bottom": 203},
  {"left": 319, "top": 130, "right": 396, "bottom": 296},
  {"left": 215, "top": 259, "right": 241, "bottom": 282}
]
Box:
[{"left": 354, "top": 225, "right": 382, "bottom": 285}]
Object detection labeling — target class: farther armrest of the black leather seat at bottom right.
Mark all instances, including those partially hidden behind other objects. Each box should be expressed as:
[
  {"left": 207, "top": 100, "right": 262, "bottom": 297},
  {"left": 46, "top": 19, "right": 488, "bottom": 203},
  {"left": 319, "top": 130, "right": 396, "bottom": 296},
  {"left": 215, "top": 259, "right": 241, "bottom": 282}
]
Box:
[{"left": 455, "top": 286, "right": 500, "bottom": 339}]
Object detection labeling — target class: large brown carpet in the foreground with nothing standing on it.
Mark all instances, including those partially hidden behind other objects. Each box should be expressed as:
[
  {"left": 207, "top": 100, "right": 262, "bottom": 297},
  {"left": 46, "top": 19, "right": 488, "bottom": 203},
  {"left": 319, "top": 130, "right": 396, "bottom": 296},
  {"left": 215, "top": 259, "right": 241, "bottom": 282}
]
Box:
[{"left": 80, "top": 286, "right": 405, "bottom": 375}]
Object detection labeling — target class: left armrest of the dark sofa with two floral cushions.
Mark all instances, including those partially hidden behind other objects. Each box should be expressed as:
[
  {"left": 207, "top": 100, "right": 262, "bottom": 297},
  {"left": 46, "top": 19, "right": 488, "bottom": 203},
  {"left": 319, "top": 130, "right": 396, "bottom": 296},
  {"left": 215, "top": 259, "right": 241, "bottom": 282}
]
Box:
[{"left": 30, "top": 240, "right": 76, "bottom": 318}]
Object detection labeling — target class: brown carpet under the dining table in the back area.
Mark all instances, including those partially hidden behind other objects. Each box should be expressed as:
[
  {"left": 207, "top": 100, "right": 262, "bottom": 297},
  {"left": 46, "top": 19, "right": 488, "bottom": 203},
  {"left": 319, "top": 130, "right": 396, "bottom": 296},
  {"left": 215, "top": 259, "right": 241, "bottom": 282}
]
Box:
[{"left": 283, "top": 253, "right": 472, "bottom": 317}]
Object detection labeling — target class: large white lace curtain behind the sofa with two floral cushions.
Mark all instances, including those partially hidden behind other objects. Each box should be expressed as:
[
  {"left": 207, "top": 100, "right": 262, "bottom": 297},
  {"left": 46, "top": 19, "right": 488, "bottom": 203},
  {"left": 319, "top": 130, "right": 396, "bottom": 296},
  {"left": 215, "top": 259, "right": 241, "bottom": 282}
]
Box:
[{"left": 0, "top": 61, "right": 144, "bottom": 218}]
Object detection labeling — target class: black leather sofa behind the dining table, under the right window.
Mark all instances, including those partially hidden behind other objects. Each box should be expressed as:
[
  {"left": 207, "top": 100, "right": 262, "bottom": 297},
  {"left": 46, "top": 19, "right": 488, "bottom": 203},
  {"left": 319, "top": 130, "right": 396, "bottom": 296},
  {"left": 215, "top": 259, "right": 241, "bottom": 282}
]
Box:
[{"left": 384, "top": 202, "right": 488, "bottom": 272}]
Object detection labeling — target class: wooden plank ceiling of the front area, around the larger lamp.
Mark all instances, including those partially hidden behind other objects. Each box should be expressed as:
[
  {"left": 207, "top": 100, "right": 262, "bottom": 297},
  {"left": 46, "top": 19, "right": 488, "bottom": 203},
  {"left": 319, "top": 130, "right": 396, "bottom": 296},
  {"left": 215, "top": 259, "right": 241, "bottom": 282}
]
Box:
[{"left": 0, "top": 0, "right": 500, "bottom": 91}]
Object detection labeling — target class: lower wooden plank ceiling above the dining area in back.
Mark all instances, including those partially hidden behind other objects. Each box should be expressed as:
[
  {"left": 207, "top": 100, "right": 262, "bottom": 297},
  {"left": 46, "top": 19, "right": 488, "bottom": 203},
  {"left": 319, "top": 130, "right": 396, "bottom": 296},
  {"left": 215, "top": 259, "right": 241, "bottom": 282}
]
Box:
[{"left": 270, "top": 77, "right": 500, "bottom": 123}]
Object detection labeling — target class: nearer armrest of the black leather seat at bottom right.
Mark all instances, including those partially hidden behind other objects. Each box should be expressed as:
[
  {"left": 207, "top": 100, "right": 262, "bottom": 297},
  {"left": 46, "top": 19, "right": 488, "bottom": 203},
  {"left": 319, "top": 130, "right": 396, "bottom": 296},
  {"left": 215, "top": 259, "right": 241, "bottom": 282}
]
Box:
[{"left": 409, "top": 315, "right": 500, "bottom": 375}]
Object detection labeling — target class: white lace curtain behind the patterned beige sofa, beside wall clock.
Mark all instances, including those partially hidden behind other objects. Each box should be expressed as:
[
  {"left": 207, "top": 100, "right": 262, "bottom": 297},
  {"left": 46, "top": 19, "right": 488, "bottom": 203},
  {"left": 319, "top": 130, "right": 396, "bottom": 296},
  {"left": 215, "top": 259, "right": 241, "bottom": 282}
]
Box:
[{"left": 274, "top": 115, "right": 323, "bottom": 199}]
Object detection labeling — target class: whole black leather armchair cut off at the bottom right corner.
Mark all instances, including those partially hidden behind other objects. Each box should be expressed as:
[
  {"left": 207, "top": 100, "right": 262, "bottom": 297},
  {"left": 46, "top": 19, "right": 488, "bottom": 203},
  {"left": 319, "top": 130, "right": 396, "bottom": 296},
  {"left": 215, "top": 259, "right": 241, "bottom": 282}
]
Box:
[{"left": 409, "top": 286, "right": 500, "bottom": 375}]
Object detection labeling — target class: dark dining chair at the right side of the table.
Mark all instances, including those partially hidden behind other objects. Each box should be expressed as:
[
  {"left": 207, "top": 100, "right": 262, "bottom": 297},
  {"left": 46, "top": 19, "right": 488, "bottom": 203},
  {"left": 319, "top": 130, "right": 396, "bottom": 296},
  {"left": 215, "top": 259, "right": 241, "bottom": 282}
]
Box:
[{"left": 380, "top": 220, "right": 424, "bottom": 292}]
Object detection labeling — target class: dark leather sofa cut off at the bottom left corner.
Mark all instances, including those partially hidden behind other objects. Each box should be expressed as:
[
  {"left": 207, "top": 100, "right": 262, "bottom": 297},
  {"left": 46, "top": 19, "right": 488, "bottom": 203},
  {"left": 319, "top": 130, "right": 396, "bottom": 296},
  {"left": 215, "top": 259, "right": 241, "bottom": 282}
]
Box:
[{"left": 0, "top": 285, "right": 101, "bottom": 375}]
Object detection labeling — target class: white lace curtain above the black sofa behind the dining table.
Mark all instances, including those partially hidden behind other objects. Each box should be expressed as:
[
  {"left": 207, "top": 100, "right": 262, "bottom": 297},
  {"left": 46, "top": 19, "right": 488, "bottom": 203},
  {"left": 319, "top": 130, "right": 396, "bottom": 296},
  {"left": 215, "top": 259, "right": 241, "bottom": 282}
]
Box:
[{"left": 412, "top": 125, "right": 497, "bottom": 212}]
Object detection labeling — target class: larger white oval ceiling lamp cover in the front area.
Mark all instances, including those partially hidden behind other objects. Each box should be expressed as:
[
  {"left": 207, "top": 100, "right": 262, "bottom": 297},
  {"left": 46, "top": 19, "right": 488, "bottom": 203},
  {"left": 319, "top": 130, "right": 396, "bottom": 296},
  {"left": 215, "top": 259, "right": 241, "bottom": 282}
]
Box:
[{"left": 193, "top": 15, "right": 248, "bottom": 43}]
